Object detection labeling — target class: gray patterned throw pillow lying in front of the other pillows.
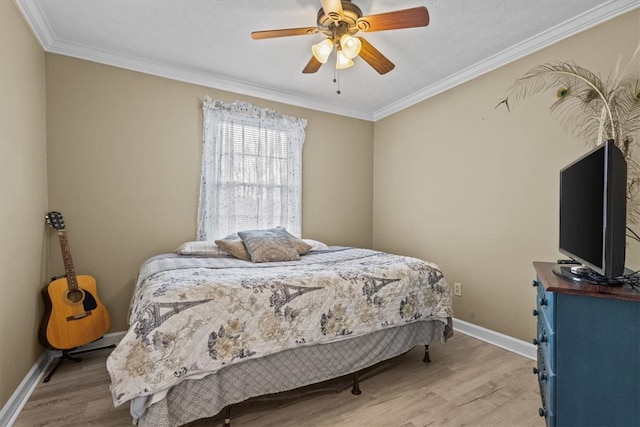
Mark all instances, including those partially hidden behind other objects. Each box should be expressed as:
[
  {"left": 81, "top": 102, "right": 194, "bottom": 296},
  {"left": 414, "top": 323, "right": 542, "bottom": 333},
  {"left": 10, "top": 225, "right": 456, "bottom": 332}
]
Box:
[{"left": 238, "top": 227, "right": 302, "bottom": 262}]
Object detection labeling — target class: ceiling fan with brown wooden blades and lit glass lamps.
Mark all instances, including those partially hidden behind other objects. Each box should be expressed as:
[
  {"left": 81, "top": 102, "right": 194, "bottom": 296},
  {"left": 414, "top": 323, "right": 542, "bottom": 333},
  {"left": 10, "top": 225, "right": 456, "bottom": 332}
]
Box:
[{"left": 251, "top": 0, "right": 429, "bottom": 74}]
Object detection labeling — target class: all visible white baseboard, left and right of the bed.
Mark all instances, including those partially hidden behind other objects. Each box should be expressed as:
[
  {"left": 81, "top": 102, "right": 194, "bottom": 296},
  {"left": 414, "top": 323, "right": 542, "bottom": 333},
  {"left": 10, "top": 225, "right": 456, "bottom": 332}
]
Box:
[{"left": 0, "top": 319, "right": 536, "bottom": 427}]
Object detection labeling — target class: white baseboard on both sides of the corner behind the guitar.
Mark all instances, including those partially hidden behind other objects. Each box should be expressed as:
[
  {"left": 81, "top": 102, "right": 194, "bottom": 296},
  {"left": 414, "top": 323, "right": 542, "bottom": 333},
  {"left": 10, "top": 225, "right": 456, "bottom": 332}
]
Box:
[{"left": 0, "top": 332, "right": 125, "bottom": 427}]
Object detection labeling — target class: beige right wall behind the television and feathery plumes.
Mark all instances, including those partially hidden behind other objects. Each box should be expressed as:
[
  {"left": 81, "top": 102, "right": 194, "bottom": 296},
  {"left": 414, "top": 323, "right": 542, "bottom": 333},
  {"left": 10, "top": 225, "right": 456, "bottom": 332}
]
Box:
[{"left": 374, "top": 11, "right": 640, "bottom": 341}]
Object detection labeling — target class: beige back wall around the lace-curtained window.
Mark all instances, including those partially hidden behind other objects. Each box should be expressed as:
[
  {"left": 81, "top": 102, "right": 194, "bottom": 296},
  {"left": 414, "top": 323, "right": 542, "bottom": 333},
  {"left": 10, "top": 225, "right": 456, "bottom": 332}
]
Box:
[{"left": 46, "top": 54, "right": 373, "bottom": 331}]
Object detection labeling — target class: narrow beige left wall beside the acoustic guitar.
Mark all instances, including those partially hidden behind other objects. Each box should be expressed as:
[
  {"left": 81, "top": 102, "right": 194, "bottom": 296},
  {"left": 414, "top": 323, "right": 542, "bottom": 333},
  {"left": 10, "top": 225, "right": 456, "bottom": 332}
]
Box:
[{"left": 0, "top": 1, "right": 47, "bottom": 407}]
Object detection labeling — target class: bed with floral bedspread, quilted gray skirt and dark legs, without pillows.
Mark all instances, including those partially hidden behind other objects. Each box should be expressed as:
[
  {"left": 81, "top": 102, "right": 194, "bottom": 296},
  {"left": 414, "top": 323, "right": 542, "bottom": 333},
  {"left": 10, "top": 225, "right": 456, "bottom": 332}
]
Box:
[{"left": 107, "top": 239, "right": 452, "bottom": 426}]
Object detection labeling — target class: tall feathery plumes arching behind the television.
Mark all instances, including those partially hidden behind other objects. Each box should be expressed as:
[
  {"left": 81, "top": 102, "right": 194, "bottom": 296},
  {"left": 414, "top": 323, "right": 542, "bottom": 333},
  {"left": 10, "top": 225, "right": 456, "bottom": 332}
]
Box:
[{"left": 498, "top": 45, "right": 640, "bottom": 223}]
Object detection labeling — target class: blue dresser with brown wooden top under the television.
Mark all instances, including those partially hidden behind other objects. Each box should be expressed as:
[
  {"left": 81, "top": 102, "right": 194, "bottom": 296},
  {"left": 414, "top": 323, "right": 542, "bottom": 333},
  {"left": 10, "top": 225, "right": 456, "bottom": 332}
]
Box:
[{"left": 533, "top": 262, "right": 640, "bottom": 427}]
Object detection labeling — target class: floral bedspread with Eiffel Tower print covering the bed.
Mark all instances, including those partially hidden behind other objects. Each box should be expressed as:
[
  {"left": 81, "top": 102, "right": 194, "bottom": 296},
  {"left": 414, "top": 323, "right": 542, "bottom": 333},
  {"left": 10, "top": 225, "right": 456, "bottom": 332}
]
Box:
[{"left": 107, "top": 247, "right": 452, "bottom": 406}]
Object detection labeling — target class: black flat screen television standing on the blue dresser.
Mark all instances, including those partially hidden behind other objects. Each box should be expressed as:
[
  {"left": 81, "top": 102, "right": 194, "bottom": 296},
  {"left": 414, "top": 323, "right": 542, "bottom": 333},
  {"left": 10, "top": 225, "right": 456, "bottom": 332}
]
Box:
[{"left": 557, "top": 140, "right": 627, "bottom": 284}]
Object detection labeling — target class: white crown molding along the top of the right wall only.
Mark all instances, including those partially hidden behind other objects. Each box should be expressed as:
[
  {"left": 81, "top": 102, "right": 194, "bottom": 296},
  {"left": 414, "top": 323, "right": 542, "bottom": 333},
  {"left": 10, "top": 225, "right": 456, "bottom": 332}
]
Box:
[{"left": 373, "top": 0, "right": 640, "bottom": 122}]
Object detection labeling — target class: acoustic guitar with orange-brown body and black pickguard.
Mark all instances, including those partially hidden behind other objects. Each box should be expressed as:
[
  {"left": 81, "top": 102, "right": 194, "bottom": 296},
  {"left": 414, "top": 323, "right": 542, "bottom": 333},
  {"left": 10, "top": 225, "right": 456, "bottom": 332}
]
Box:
[{"left": 39, "top": 212, "right": 111, "bottom": 350}]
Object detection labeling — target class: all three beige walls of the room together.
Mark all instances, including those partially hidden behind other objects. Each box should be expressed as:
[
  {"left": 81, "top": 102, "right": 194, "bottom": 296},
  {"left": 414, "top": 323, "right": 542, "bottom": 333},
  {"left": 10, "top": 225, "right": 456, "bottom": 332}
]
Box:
[{"left": 0, "top": 1, "right": 640, "bottom": 412}]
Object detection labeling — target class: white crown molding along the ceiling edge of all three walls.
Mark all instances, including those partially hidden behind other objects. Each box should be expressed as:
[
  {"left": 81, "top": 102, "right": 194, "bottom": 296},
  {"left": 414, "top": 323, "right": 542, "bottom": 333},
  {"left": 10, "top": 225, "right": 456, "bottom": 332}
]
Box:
[{"left": 14, "top": 0, "right": 640, "bottom": 122}]
